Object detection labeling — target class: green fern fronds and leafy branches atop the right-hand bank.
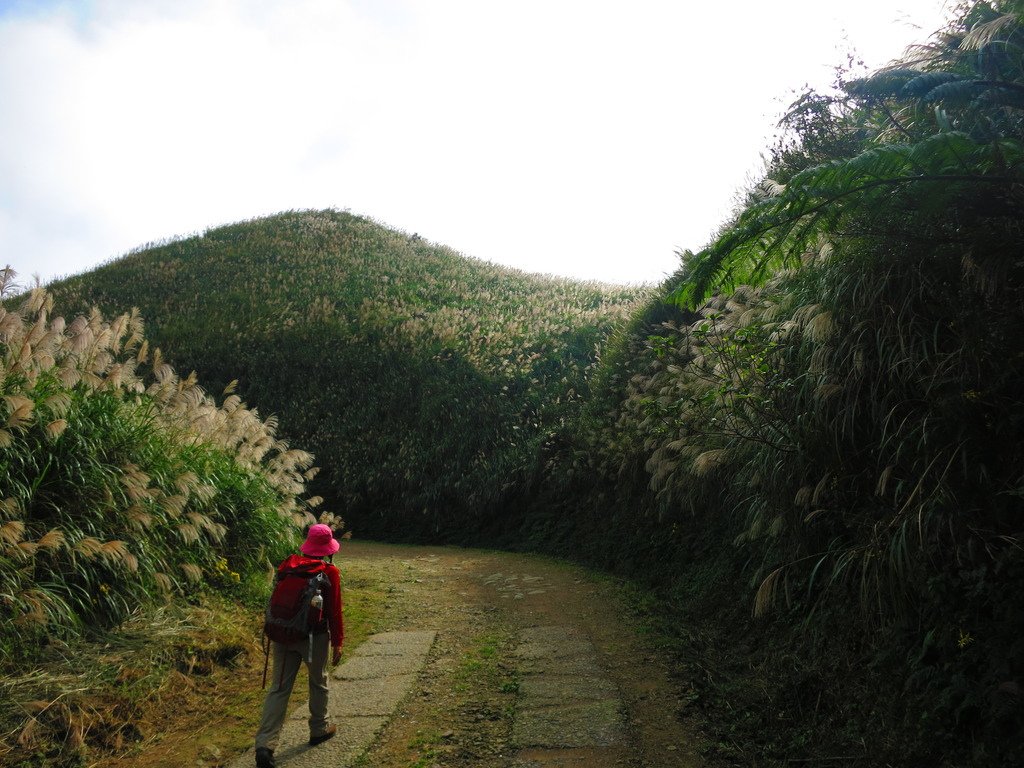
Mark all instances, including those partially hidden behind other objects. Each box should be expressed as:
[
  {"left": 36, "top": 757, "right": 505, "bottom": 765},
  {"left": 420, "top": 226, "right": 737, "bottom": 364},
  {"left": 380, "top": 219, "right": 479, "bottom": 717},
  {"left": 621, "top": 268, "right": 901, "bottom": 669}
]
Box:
[{"left": 676, "top": 2, "right": 1024, "bottom": 307}]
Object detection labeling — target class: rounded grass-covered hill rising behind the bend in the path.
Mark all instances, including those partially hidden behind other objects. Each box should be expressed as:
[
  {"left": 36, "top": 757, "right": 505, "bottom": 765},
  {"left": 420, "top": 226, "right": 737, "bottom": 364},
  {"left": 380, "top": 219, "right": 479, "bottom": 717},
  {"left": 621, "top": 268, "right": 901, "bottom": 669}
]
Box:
[{"left": 50, "top": 211, "right": 645, "bottom": 539}]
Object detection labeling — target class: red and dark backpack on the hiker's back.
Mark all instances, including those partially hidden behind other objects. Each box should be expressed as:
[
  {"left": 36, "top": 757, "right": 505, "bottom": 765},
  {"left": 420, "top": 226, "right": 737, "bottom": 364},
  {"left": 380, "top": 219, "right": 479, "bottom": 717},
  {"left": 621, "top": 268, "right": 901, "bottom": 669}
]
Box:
[{"left": 263, "top": 555, "right": 331, "bottom": 652}]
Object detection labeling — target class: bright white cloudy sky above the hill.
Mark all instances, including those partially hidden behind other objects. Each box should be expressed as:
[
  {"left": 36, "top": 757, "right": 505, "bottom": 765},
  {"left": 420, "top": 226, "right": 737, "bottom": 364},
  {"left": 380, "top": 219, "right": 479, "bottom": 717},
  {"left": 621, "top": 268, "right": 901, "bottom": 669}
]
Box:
[{"left": 0, "top": 0, "right": 943, "bottom": 283}]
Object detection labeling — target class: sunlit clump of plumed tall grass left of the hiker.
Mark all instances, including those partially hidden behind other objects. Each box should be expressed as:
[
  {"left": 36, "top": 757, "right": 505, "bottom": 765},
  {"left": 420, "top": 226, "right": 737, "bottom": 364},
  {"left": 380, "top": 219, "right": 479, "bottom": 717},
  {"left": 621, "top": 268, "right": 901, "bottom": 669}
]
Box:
[{"left": 0, "top": 270, "right": 315, "bottom": 664}]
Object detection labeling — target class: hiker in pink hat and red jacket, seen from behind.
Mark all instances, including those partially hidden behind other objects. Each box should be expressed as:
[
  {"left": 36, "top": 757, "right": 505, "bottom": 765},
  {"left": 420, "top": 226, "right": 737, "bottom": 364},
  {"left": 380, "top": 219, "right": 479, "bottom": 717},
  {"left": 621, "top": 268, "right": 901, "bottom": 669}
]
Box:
[{"left": 256, "top": 523, "right": 344, "bottom": 768}]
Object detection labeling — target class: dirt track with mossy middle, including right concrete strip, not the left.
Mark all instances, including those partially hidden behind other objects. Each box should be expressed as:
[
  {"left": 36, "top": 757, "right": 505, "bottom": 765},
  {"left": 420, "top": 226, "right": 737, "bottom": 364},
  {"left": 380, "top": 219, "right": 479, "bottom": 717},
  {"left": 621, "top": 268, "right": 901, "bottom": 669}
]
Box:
[{"left": 307, "top": 543, "right": 700, "bottom": 768}]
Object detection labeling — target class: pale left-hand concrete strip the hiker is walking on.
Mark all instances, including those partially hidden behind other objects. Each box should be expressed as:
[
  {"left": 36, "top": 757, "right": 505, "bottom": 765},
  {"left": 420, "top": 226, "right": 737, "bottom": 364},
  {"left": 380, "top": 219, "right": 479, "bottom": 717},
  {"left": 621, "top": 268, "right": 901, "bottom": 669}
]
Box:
[{"left": 229, "top": 632, "right": 436, "bottom": 768}]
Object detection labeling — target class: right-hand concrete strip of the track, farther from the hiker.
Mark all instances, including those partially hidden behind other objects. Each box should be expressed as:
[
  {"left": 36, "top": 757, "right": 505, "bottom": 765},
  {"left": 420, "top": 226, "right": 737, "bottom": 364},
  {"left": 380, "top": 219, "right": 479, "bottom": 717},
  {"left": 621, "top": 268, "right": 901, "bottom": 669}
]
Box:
[{"left": 512, "top": 627, "right": 626, "bottom": 768}]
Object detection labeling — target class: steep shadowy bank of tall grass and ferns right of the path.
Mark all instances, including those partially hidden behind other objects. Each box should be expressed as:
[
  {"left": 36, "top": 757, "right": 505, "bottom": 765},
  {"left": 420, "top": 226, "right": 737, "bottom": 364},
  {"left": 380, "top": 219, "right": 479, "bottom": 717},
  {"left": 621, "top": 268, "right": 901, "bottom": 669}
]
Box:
[{"left": 535, "top": 1, "right": 1024, "bottom": 765}]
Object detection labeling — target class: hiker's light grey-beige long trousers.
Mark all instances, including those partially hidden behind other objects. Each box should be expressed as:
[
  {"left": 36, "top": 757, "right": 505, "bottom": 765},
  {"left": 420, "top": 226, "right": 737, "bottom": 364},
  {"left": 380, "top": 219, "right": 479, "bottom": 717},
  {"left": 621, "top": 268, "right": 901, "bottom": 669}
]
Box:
[{"left": 256, "top": 632, "right": 331, "bottom": 750}]
